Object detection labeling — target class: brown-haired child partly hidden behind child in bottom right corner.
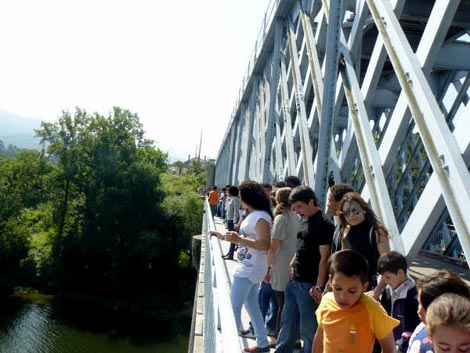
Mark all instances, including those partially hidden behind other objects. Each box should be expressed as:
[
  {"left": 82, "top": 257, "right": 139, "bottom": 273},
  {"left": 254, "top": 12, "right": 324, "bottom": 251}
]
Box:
[{"left": 407, "top": 270, "right": 470, "bottom": 353}]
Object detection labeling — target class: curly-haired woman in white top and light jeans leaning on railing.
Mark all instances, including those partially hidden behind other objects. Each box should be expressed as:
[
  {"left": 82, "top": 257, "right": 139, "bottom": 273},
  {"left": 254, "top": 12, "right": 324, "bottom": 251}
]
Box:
[{"left": 210, "top": 181, "right": 273, "bottom": 352}]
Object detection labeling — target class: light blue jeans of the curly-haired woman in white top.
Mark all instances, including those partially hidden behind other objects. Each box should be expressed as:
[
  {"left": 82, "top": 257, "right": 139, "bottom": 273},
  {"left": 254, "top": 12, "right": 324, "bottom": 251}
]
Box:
[{"left": 230, "top": 277, "right": 269, "bottom": 347}]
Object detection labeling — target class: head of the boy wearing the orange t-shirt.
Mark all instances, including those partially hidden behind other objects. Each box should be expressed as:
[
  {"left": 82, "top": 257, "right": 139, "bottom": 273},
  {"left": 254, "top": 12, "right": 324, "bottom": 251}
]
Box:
[{"left": 328, "top": 249, "right": 369, "bottom": 309}]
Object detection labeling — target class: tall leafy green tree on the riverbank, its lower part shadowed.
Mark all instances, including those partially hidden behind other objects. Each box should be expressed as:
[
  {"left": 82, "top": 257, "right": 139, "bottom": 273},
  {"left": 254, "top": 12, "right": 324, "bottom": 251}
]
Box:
[{"left": 37, "top": 108, "right": 193, "bottom": 315}]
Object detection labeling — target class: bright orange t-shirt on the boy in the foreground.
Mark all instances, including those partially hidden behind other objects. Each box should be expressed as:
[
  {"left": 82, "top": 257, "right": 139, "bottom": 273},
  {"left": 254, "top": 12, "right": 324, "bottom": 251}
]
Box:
[{"left": 316, "top": 293, "right": 400, "bottom": 353}]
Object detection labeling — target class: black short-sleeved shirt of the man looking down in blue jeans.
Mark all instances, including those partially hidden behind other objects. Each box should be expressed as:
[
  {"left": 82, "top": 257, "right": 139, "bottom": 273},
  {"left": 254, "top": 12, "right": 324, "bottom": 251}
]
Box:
[{"left": 294, "top": 211, "right": 335, "bottom": 283}]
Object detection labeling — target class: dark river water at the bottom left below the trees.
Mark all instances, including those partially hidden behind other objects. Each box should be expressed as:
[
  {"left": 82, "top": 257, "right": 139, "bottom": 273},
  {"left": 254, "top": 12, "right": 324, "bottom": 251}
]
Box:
[{"left": 0, "top": 295, "right": 188, "bottom": 353}]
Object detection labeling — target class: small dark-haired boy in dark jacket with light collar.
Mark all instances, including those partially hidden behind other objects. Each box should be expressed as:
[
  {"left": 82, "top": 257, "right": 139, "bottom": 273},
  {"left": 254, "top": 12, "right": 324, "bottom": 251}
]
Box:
[{"left": 377, "top": 251, "right": 420, "bottom": 352}]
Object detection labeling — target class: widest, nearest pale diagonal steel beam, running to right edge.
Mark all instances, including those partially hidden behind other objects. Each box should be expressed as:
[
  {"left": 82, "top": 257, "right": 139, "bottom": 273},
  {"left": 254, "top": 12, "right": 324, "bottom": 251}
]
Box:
[{"left": 367, "top": 0, "right": 470, "bottom": 258}]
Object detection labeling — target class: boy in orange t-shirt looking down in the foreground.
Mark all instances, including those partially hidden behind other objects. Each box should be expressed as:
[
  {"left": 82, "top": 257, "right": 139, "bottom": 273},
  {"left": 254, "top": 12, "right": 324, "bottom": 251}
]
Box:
[{"left": 312, "top": 250, "right": 400, "bottom": 353}]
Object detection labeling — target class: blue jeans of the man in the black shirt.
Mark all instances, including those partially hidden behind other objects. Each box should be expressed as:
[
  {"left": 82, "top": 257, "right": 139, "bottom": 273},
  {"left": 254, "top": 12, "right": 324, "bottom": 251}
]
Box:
[{"left": 276, "top": 280, "right": 318, "bottom": 353}]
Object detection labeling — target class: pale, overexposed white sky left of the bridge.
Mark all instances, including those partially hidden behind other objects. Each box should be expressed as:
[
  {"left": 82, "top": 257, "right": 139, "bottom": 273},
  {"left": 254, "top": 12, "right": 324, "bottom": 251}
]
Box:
[{"left": 0, "top": 0, "right": 270, "bottom": 160}]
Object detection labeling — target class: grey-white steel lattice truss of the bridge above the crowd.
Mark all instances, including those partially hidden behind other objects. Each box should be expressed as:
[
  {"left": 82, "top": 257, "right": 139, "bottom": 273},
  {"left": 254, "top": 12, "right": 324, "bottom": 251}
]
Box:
[{"left": 215, "top": 0, "right": 470, "bottom": 262}]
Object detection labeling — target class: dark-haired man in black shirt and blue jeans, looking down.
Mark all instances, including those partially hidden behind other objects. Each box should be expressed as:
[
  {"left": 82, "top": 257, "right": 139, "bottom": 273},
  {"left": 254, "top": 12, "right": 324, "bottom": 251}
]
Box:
[{"left": 276, "top": 186, "right": 334, "bottom": 353}]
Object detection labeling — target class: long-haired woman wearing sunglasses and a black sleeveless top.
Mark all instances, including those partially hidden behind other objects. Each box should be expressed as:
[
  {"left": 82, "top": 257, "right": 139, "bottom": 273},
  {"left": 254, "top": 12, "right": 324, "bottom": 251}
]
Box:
[{"left": 339, "top": 192, "right": 390, "bottom": 300}]
